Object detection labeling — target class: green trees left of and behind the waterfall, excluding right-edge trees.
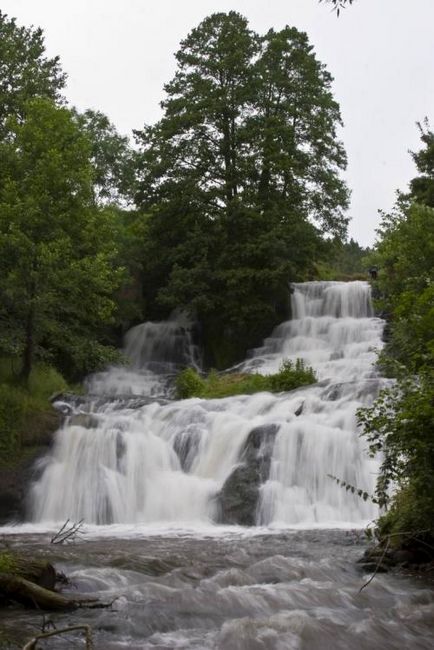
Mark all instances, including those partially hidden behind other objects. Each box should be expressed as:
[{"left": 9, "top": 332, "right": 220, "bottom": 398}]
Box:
[{"left": 0, "top": 12, "right": 362, "bottom": 385}]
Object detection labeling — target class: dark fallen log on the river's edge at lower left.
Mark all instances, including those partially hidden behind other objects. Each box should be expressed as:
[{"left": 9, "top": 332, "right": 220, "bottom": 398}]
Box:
[{"left": 0, "top": 573, "right": 102, "bottom": 611}]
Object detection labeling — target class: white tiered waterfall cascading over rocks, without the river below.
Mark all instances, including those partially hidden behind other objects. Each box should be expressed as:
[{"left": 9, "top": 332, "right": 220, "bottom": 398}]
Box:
[{"left": 30, "top": 282, "right": 383, "bottom": 527}]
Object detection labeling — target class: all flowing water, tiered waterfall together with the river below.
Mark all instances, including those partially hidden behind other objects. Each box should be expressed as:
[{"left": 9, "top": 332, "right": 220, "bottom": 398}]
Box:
[{"left": 0, "top": 282, "right": 434, "bottom": 650}]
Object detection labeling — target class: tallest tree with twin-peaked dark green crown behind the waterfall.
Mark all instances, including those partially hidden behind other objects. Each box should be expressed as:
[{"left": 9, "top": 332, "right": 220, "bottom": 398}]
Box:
[{"left": 136, "top": 11, "right": 347, "bottom": 364}]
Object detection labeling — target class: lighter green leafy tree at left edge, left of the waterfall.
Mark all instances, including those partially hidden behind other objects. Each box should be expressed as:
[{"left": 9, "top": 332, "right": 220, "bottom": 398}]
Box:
[{"left": 0, "top": 99, "right": 124, "bottom": 380}]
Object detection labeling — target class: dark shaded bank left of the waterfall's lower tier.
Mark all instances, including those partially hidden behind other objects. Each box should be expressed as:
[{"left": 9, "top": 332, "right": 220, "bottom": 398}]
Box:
[{"left": 0, "top": 408, "right": 62, "bottom": 524}]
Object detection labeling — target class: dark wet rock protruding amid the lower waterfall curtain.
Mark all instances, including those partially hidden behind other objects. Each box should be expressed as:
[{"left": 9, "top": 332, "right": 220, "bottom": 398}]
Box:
[{"left": 217, "top": 424, "right": 279, "bottom": 526}]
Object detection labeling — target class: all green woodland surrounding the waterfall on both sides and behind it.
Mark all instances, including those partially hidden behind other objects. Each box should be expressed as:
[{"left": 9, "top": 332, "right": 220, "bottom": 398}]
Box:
[{"left": 0, "top": 3, "right": 434, "bottom": 547}]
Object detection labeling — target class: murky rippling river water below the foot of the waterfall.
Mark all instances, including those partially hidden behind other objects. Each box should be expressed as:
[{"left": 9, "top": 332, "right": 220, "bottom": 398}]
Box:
[{"left": 0, "top": 529, "right": 434, "bottom": 650}]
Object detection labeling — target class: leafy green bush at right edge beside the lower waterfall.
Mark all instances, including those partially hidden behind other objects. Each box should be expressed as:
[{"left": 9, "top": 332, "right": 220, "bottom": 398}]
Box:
[{"left": 358, "top": 370, "right": 434, "bottom": 554}]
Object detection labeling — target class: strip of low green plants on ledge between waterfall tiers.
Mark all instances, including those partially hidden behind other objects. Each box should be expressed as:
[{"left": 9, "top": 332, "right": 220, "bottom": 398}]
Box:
[{"left": 176, "top": 359, "right": 316, "bottom": 399}]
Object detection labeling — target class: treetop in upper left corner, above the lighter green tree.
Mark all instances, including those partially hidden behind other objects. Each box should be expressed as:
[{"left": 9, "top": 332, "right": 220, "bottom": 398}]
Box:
[{"left": 0, "top": 11, "right": 66, "bottom": 138}]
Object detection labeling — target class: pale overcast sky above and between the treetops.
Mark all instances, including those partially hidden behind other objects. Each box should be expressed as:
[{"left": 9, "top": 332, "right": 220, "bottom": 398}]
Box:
[{"left": 0, "top": 0, "right": 434, "bottom": 246}]
